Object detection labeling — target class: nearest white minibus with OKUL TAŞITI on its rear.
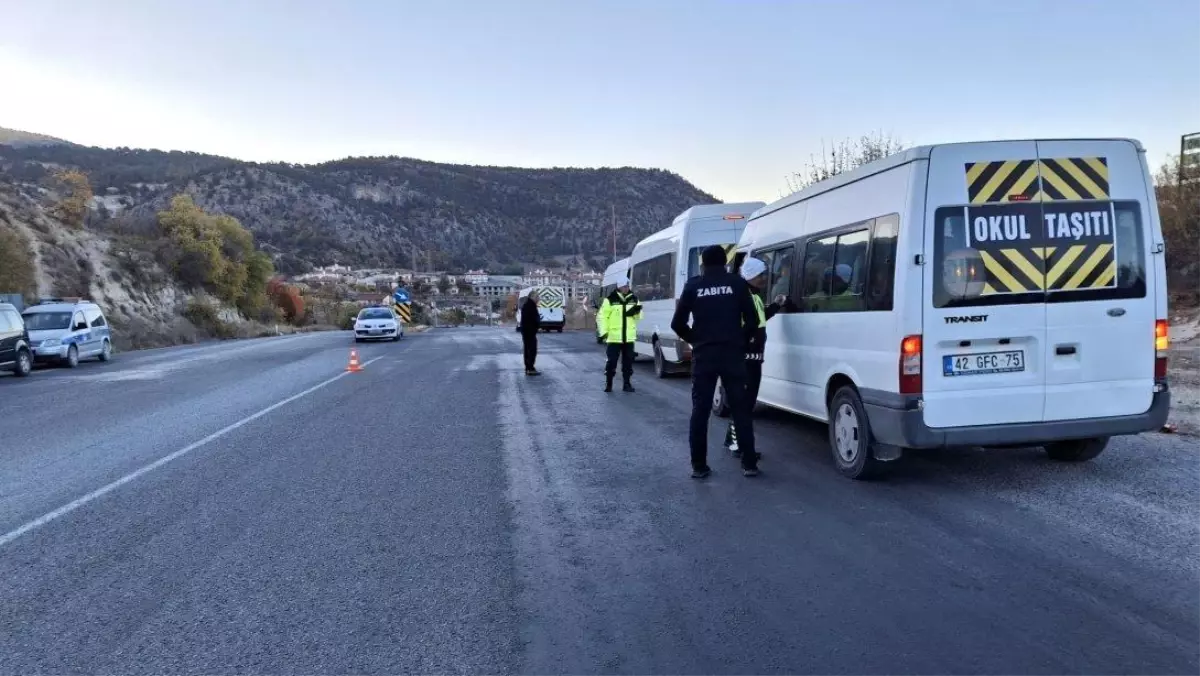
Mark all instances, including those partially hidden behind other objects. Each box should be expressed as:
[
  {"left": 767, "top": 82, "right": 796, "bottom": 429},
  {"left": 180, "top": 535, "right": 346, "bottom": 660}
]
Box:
[{"left": 729, "top": 139, "right": 1170, "bottom": 478}]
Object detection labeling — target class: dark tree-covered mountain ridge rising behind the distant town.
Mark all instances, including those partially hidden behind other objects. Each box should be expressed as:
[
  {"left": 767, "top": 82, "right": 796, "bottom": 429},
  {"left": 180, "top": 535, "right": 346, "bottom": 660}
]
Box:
[{"left": 0, "top": 136, "right": 718, "bottom": 273}]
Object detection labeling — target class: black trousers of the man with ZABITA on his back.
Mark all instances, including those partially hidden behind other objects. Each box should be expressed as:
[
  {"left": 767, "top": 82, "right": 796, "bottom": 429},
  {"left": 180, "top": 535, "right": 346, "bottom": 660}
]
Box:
[{"left": 688, "top": 353, "right": 758, "bottom": 469}]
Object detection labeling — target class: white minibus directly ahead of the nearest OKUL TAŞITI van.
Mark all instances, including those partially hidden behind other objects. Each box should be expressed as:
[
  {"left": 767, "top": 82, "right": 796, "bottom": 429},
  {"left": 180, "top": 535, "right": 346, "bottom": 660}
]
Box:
[{"left": 629, "top": 202, "right": 764, "bottom": 378}]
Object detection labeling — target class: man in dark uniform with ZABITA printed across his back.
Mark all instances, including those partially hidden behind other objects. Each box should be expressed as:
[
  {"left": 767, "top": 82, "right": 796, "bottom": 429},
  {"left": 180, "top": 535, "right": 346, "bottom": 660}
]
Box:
[{"left": 671, "top": 246, "right": 758, "bottom": 479}]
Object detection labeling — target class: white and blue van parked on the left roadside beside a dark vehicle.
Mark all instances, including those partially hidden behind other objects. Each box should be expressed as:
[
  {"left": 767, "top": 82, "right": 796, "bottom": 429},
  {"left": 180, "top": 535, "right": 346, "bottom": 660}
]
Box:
[{"left": 22, "top": 298, "right": 113, "bottom": 369}]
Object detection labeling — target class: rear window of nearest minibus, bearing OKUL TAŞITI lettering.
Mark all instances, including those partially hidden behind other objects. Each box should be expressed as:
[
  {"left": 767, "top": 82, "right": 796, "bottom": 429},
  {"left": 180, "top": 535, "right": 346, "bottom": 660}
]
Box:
[{"left": 934, "top": 202, "right": 1146, "bottom": 307}]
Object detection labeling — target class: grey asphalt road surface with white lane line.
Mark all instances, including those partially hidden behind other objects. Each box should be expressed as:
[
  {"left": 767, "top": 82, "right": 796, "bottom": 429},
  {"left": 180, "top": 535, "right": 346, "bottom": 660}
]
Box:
[{"left": 0, "top": 329, "right": 1200, "bottom": 676}]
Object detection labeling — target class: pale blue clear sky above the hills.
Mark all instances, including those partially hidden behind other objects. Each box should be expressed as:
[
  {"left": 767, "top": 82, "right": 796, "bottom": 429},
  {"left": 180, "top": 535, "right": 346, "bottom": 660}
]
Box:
[{"left": 0, "top": 0, "right": 1200, "bottom": 202}]
